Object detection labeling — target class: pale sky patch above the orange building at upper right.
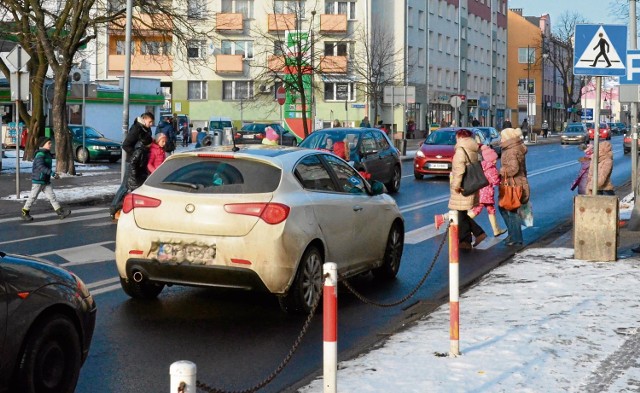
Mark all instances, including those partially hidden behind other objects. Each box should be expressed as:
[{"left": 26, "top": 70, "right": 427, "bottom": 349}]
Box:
[{"left": 509, "top": 0, "right": 624, "bottom": 25}]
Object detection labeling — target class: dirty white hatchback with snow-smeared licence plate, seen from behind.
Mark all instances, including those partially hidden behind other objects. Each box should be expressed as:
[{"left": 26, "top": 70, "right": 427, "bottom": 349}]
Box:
[{"left": 116, "top": 145, "right": 404, "bottom": 313}]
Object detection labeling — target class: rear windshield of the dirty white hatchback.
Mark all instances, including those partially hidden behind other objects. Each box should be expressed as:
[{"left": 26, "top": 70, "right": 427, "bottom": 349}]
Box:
[{"left": 145, "top": 156, "right": 282, "bottom": 194}]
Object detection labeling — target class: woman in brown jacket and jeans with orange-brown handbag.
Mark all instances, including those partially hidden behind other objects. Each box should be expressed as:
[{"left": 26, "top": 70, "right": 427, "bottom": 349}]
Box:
[{"left": 500, "top": 128, "right": 530, "bottom": 246}]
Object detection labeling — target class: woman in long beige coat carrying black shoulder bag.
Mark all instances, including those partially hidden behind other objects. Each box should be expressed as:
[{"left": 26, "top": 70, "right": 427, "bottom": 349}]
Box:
[{"left": 449, "top": 128, "right": 487, "bottom": 250}]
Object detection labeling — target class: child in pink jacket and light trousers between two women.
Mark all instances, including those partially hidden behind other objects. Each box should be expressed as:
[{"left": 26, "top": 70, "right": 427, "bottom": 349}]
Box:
[{"left": 468, "top": 145, "right": 507, "bottom": 237}]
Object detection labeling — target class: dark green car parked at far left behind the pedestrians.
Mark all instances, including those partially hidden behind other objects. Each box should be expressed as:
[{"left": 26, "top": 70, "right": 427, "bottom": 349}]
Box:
[{"left": 66, "top": 124, "right": 122, "bottom": 163}]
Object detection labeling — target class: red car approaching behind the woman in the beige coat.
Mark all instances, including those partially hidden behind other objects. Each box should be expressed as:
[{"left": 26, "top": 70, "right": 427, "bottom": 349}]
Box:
[{"left": 413, "top": 127, "right": 494, "bottom": 180}]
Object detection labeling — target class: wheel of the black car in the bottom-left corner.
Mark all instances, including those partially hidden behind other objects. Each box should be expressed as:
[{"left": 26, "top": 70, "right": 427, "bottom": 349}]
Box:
[{"left": 13, "top": 314, "right": 82, "bottom": 393}]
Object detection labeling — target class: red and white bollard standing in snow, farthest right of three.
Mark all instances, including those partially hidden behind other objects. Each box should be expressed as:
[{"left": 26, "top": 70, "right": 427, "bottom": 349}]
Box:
[{"left": 449, "top": 210, "right": 460, "bottom": 357}]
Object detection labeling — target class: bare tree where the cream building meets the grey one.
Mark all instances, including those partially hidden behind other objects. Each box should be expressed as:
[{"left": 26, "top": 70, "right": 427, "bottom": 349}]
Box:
[{"left": 353, "top": 20, "right": 404, "bottom": 126}]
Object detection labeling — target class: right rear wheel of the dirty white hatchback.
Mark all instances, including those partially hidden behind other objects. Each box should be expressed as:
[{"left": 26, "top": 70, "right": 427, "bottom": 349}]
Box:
[{"left": 278, "top": 246, "right": 324, "bottom": 314}]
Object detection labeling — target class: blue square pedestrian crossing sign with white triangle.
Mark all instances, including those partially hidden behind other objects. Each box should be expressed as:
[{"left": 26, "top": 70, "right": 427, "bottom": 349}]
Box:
[{"left": 573, "top": 24, "right": 627, "bottom": 76}]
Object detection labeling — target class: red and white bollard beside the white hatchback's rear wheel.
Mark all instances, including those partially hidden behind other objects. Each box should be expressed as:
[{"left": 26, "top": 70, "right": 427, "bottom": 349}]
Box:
[{"left": 322, "top": 262, "right": 338, "bottom": 393}]
